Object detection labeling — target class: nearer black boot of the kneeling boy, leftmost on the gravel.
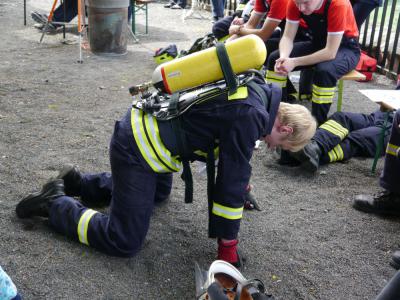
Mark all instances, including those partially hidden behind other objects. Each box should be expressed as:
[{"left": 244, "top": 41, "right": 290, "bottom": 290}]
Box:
[{"left": 15, "top": 179, "right": 65, "bottom": 219}]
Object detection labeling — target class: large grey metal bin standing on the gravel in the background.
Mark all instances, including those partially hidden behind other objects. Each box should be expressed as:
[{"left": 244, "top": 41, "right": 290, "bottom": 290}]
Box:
[{"left": 88, "top": 0, "right": 129, "bottom": 56}]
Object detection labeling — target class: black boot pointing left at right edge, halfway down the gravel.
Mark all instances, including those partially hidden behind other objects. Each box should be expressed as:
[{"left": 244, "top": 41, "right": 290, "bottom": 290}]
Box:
[{"left": 353, "top": 191, "right": 400, "bottom": 216}]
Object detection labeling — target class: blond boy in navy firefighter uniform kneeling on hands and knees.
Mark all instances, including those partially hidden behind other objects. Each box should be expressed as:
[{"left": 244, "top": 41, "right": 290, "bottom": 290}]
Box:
[{"left": 16, "top": 38, "right": 316, "bottom": 265}]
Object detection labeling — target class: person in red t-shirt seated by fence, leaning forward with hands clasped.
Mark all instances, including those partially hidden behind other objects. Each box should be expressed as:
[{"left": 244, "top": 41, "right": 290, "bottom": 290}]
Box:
[{"left": 267, "top": 0, "right": 360, "bottom": 124}]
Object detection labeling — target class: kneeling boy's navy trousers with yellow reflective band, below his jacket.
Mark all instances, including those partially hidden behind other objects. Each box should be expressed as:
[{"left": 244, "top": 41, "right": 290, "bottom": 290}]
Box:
[{"left": 49, "top": 113, "right": 172, "bottom": 256}]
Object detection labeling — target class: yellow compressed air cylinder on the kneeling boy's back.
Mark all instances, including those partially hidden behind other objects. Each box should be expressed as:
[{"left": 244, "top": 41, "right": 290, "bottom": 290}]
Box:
[{"left": 152, "top": 34, "right": 267, "bottom": 94}]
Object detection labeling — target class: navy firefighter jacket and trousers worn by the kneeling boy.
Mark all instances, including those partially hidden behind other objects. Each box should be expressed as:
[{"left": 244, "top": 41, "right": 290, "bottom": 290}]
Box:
[{"left": 49, "top": 79, "right": 280, "bottom": 256}]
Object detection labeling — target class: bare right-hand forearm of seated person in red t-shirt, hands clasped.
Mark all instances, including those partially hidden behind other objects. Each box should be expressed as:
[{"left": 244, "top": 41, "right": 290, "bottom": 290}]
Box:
[{"left": 277, "top": 34, "right": 343, "bottom": 73}]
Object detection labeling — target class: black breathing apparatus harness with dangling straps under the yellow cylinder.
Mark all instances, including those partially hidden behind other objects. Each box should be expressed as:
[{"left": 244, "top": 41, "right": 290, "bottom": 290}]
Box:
[{"left": 129, "top": 43, "right": 270, "bottom": 238}]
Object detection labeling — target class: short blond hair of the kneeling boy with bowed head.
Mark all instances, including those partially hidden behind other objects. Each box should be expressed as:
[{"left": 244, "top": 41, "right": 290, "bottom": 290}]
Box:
[{"left": 278, "top": 102, "right": 317, "bottom": 152}]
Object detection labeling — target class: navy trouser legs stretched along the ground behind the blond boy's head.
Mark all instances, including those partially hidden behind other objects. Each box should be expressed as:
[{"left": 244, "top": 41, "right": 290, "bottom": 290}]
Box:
[{"left": 313, "top": 110, "right": 393, "bottom": 164}]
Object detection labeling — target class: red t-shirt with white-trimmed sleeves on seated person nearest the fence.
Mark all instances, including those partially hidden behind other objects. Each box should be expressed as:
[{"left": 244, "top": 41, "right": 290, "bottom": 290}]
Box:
[{"left": 286, "top": 0, "right": 358, "bottom": 38}]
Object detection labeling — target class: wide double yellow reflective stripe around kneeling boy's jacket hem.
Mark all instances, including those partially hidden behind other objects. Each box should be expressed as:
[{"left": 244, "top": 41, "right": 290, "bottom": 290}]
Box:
[{"left": 131, "top": 108, "right": 180, "bottom": 173}]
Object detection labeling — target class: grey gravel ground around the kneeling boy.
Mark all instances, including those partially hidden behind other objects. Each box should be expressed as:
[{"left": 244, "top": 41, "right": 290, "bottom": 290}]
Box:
[{"left": 0, "top": 0, "right": 399, "bottom": 299}]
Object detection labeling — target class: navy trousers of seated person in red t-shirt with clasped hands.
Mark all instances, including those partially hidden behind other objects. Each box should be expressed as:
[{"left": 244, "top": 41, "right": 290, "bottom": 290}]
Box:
[{"left": 267, "top": 40, "right": 360, "bottom": 124}]
